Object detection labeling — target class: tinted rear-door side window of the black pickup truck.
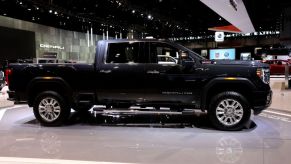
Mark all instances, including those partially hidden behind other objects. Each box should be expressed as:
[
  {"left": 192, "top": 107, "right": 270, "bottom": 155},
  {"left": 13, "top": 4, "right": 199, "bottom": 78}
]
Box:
[{"left": 106, "top": 42, "right": 140, "bottom": 63}]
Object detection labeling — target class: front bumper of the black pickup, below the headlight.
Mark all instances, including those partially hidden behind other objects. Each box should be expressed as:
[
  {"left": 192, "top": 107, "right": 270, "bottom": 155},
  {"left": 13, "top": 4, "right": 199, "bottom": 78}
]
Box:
[{"left": 252, "top": 90, "right": 273, "bottom": 115}]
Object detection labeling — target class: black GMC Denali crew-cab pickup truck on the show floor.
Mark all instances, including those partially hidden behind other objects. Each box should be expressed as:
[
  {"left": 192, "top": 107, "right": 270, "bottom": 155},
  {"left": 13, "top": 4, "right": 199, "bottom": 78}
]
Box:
[{"left": 6, "top": 40, "right": 272, "bottom": 130}]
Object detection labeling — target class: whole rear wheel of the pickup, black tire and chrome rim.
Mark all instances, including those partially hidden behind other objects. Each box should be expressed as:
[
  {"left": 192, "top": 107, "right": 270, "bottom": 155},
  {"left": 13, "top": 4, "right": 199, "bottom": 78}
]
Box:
[{"left": 33, "top": 91, "right": 70, "bottom": 126}]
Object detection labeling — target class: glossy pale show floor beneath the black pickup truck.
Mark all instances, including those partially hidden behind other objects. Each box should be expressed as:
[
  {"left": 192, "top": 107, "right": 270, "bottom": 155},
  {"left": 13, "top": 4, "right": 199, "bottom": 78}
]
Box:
[{"left": 0, "top": 105, "right": 291, "bottom": 164}]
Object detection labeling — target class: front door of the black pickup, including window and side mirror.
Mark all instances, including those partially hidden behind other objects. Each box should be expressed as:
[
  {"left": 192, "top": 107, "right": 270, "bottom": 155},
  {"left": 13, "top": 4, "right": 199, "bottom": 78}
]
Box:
[{"left": 145, "top": 42, "right": 199, "bottom": 105}]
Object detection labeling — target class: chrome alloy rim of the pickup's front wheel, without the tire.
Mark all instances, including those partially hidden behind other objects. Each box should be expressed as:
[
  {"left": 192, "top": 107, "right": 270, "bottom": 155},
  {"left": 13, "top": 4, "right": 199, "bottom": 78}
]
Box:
[{"left": 216, "top": 99, "right": 244, "bottom": 126}]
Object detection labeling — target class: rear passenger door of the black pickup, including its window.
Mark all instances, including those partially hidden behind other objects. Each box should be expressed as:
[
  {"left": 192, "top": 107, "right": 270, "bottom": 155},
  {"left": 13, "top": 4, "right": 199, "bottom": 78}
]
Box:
[{"left": 96, "top": 42, "right": 145, "bottom": 102}]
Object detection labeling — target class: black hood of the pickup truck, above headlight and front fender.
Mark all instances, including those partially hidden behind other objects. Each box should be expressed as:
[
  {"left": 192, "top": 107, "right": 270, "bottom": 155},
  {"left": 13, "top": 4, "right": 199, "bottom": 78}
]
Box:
[{"left": 203, "top": 60, "right": 269, "bottom": 67}]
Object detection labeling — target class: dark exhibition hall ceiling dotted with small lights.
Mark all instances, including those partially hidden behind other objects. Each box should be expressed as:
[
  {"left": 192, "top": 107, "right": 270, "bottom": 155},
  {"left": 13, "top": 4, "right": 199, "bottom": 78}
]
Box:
[{"left": 0, "top": 0, "right": 291, "bottom": 38}]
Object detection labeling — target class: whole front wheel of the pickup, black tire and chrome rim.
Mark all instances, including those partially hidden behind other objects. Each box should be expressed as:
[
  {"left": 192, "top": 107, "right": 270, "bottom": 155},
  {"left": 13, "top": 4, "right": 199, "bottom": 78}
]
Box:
[{"left": 208, "top": 91, "right": 251, "bottom": 131}]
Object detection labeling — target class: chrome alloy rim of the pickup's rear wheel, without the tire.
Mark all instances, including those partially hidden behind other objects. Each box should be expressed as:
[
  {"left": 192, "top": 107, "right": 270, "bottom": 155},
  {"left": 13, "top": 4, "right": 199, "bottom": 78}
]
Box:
[{"left": 38, "top": 97, "right": 61, "bottom": 122}]
